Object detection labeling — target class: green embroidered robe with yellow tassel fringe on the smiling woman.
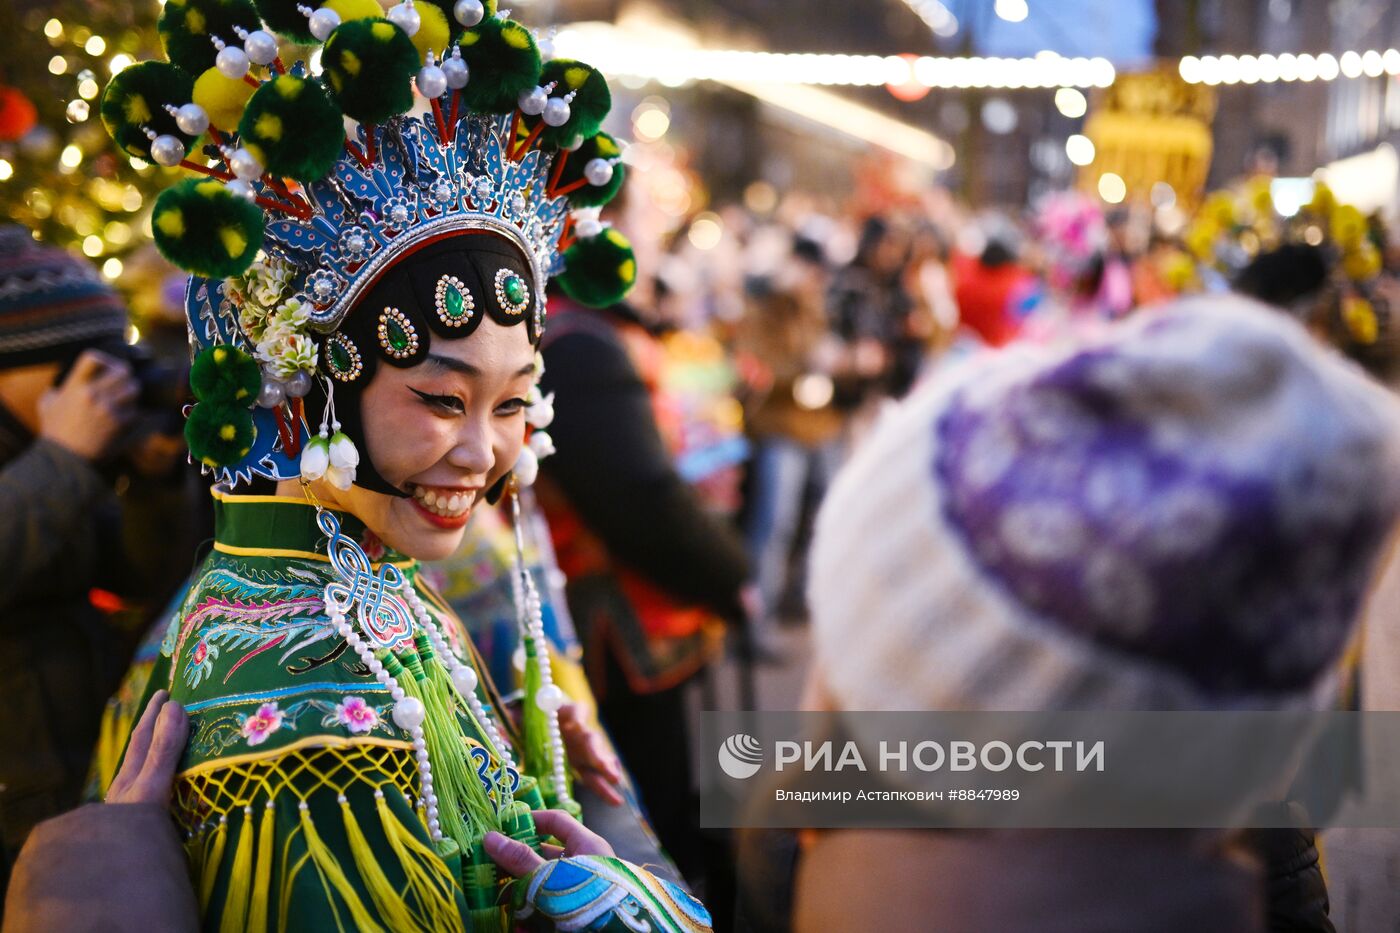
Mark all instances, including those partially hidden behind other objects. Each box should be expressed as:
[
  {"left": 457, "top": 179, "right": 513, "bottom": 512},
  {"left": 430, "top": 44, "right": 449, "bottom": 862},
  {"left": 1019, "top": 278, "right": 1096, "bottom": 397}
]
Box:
[{"left": 97, "top": 493, "right": 526, "bottom": 930}]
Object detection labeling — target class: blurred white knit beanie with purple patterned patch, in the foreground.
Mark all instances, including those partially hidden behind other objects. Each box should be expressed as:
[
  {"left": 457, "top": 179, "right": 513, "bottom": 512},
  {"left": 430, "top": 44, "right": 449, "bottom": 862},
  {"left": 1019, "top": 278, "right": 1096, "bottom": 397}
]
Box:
[{"left": 809, "top": 297, "right": 1400, "bottom": 710}]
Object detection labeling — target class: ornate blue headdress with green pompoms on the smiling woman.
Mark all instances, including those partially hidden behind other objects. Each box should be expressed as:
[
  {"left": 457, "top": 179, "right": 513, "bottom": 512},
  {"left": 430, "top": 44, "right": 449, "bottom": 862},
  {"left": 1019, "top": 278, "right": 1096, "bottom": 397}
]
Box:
[{"left": 101, "top": 0, "right": 636, "bottom": 493}]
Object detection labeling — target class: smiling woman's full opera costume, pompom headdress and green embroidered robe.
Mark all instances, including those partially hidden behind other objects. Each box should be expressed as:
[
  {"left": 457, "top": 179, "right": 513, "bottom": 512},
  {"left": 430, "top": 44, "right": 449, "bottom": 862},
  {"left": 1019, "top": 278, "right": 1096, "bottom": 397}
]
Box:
[{"left": 98, "top": 0, "right": 707, "bottom": 930}]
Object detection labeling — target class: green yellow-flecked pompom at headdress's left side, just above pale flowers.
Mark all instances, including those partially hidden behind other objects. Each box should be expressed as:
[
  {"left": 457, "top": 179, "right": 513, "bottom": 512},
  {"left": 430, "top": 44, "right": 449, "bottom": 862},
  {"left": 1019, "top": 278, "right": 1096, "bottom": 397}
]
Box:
[{"left": 151, "top": 178, "right": 265, "bottom": 279}]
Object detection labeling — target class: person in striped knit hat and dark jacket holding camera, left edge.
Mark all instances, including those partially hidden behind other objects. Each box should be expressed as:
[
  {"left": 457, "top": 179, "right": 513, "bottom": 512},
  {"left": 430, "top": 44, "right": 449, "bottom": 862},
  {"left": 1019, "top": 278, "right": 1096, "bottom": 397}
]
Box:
[{"left": 0, "top": 227, "right": 137, "bottom": 881}]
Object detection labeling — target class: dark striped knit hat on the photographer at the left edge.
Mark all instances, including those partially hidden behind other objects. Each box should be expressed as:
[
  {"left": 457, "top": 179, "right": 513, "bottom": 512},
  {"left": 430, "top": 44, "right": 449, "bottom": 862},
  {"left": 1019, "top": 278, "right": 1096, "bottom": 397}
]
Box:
[{"left": 0, "top": 224, "right": 126, "bottom": 370}]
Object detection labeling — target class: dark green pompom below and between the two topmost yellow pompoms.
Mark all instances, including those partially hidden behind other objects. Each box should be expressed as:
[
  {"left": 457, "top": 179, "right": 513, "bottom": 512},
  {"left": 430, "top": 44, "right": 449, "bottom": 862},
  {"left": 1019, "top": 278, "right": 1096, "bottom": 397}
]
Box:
[{"left": 321, "top": 20, "right": 419, "bottom": 126}]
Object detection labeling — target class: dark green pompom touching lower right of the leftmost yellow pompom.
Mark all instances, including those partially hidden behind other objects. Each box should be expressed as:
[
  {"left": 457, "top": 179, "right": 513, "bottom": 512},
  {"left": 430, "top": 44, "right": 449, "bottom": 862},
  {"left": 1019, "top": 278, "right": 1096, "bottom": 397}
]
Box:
[{"left": 238, "top": 74, "right": 344, "bottom": 182}]
